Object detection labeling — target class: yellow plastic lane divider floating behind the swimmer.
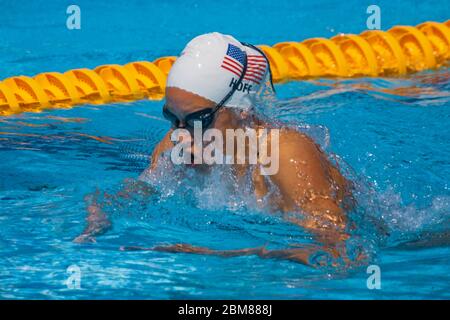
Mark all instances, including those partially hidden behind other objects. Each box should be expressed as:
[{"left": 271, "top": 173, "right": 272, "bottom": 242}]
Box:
[{"left": 0, "top": 20, "right": 450, "bottom": 116}]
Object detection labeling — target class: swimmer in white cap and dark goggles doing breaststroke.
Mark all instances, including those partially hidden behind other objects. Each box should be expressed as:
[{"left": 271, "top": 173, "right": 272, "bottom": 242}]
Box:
[{"left": 75, "top": 33, "right": 353, "bottom": 265}]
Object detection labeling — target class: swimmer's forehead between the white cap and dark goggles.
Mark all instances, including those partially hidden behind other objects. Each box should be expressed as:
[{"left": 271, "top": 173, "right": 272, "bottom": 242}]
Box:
[{"left": 166, "top": 87, "right": 216, "bottom": 128}]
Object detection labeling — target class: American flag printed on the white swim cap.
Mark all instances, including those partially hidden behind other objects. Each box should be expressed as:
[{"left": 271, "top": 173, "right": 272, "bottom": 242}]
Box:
[{"left": 221, "top": 44, "right": 267, "bottom": 84}]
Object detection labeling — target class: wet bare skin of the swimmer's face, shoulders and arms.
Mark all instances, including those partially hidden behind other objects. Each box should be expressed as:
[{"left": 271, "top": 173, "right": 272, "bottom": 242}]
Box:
[{"left": 75, "top": 88, "right": 353, "bottom": 265}]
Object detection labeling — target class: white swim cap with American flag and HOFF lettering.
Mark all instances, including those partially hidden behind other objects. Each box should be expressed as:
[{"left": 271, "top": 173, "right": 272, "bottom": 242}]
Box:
[{"left": 166, "top": 32, "right": 268, "bottom": 108}]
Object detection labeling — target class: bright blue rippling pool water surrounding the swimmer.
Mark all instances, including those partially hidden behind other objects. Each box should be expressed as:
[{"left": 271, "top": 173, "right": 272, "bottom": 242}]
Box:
[{"left": 0, "top": 0, "right": 450, "bottom": 299}]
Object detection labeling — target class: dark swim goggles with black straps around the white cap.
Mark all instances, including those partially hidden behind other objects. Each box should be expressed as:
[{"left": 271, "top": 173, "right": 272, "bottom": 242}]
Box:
[{"left": 163, "top": 42, "right": 275, "bottom": 129}]
